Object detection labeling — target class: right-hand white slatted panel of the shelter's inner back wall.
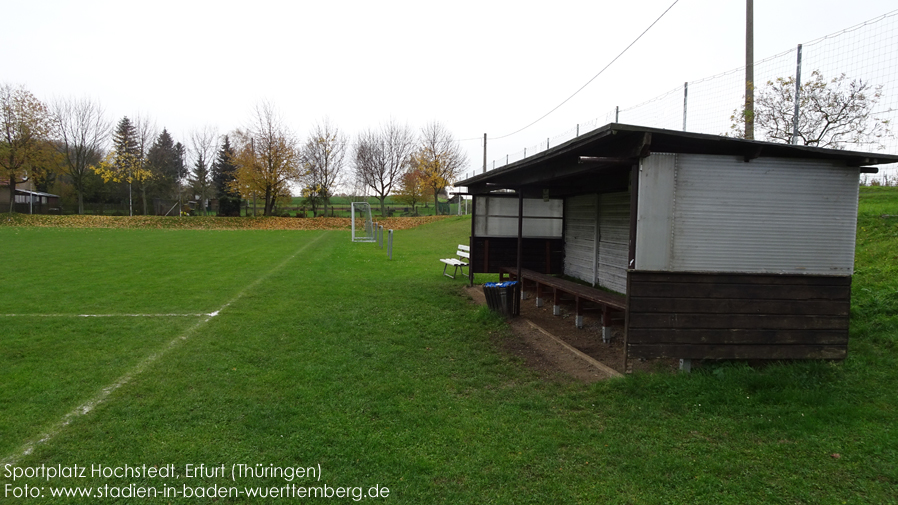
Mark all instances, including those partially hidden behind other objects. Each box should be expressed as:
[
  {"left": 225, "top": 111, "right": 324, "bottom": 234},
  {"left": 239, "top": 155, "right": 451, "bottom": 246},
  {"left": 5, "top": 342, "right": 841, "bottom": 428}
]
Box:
[{"left": 596, "top": 192, "right": 630, "bottom": 293}]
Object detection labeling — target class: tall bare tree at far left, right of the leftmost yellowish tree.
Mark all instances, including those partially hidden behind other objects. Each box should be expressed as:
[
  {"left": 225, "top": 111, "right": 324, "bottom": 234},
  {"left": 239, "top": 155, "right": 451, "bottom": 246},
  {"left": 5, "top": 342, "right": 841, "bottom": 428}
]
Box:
[{"left": 53, "top": 98, "right": 111, "bottom": 214}]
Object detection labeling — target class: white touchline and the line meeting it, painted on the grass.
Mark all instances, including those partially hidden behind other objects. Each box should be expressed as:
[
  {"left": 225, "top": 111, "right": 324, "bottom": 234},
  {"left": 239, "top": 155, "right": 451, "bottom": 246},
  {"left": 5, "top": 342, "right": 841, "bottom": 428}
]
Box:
[{"left": 0, "top": 233, "right": 324, "bottom": 466}]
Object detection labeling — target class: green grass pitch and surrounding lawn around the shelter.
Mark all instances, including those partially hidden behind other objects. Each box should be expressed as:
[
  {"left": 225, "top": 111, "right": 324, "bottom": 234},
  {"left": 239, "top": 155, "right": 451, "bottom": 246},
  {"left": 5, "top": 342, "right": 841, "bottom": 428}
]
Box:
[{"left": 0, "top": 188, "right": 898, "bottom": 504}]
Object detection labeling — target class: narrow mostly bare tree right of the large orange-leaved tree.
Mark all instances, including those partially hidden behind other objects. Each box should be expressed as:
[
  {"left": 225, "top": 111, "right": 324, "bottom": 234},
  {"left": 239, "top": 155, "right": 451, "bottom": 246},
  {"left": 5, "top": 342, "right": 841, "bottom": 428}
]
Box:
[{"left": 302, "top": 118, "right": 348, "bottom": 216}]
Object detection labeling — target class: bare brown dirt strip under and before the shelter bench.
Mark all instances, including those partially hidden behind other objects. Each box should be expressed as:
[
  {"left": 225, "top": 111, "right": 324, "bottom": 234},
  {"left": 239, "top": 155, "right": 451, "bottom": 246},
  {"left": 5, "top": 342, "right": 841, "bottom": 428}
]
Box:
[{"left": 463, "top": 284, "right": 679, "bottom": 382}]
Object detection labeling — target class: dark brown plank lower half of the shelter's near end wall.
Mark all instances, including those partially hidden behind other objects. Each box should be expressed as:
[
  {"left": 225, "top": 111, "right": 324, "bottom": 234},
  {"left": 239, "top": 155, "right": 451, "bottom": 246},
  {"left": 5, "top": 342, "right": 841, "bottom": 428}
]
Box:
[{"left": 626, "top": 270, "right": 851, "bottom": 359}]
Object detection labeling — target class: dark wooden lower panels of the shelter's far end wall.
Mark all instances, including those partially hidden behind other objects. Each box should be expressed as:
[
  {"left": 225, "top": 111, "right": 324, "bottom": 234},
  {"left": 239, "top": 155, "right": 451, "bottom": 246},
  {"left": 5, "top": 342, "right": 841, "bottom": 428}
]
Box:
[{"left": 471, "top": 237, "right": 564, "bottom": 274}]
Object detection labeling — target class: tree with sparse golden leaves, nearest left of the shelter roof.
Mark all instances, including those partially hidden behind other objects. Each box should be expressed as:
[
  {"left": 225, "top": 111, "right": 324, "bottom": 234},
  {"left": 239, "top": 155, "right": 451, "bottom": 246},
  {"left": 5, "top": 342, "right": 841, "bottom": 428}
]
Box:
[{"left": 412, "top": 121, "right": 468, "bottom": 214}]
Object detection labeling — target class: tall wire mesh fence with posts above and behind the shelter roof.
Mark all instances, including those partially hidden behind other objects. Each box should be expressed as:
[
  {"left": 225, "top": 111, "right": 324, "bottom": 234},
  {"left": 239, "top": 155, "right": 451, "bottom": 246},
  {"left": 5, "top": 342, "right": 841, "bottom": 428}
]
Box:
[{"left": 463, "top": 11, "right": 898, "bottom": 185}]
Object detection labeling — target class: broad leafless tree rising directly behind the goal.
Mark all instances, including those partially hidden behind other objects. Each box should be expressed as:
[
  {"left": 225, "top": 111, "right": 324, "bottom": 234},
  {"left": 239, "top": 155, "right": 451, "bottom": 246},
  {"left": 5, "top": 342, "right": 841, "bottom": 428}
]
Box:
[{"left": 353, "top": 121, "right": 415, "bottom": 216}]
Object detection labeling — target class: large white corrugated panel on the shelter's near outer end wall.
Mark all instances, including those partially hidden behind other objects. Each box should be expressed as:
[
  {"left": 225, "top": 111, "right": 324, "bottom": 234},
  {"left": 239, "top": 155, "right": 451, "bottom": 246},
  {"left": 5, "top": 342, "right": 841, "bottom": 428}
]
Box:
[{"left": 668, "top": 154, "right": 858, "bottom": 275}]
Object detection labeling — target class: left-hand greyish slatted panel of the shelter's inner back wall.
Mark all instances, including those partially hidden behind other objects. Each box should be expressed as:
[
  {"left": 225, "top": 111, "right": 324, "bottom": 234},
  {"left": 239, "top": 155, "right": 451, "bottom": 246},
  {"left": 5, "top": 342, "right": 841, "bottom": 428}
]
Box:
[{"left": 564, "top": 194, "right": 599, "bottom": 283}]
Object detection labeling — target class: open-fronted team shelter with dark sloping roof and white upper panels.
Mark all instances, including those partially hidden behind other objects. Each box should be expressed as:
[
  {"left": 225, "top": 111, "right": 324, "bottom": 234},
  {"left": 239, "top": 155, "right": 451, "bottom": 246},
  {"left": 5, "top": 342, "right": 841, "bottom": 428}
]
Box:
[{"left": 456, "top": 124, "right": 898, "bottom": 360}]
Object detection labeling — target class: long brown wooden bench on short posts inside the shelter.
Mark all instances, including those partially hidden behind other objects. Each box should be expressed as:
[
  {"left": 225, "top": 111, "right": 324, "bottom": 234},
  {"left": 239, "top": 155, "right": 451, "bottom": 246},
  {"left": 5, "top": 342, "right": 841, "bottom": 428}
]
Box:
[{"left": 499, "top": 267, "right": 627, "bottom": 342}]
